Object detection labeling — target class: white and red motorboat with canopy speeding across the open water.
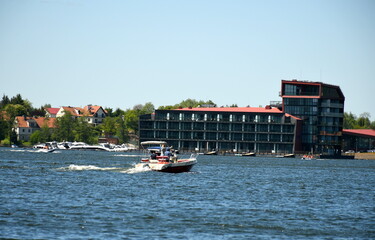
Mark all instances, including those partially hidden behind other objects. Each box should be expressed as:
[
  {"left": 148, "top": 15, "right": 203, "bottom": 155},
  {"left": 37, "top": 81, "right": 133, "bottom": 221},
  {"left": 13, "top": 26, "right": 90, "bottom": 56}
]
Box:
[{"left": 136, "top": 141, "right": 198, "bottom": 173}]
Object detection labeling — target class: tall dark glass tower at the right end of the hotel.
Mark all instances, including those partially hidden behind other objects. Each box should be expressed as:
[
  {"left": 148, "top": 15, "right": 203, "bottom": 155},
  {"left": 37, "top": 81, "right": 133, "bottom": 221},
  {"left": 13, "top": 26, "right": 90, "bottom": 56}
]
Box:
[{"left": 282, "top": 81, "right": 345, "bottom": 154}]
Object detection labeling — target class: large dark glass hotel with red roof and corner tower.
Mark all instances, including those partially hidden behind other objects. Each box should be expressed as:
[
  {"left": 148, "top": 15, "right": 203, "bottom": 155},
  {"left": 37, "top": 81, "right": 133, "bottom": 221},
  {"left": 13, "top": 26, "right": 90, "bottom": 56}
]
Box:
[{"left": 139, "top": 80, "right": 345, "bottom": 154}]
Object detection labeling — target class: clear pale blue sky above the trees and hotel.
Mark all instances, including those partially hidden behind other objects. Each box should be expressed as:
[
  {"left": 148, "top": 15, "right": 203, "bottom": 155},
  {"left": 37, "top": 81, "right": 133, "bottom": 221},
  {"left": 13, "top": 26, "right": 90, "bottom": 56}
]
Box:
[{"left": 0, "top": 0, "right": 375, "bottom": 120}]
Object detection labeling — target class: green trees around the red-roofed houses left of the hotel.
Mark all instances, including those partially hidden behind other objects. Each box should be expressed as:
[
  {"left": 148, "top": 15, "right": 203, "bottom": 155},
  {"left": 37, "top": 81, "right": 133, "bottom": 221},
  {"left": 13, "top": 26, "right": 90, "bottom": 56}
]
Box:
[{"left": 0, "top": 94, "right": 216, "bottom": 145}]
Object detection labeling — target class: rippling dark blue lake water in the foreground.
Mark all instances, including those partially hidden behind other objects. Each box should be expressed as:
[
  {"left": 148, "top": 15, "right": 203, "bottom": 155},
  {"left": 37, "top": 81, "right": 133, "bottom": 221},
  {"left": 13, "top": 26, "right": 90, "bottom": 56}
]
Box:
[{"left": 0, "top": 148, "right": 375, "bottom": 239}]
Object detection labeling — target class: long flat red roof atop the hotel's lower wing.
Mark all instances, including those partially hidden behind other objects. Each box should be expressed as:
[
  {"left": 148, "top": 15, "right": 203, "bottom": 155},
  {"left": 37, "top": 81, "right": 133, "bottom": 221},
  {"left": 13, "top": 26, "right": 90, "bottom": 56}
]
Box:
[{"left": 173, "top": 107, "right": 283, "bottom": 113}]
